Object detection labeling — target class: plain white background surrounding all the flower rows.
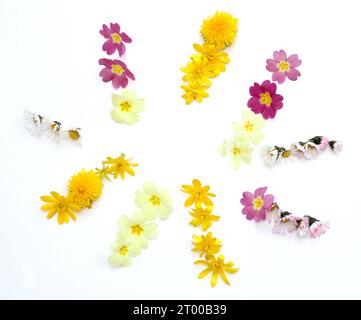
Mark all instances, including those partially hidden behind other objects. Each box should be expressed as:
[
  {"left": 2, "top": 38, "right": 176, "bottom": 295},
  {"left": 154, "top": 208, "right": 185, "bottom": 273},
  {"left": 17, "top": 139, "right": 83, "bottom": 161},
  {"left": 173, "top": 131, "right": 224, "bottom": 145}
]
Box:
[{"left": 0, "top": 0, "right": 361, "bottom": 299}]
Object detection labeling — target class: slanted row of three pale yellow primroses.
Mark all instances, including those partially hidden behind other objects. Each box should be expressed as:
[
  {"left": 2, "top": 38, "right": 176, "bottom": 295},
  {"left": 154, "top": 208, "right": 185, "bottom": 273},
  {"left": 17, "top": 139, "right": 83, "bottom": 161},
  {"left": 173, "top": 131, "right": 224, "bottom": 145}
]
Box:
[{"left": 108, "top": 183, "right": 173, "bottom": 267}]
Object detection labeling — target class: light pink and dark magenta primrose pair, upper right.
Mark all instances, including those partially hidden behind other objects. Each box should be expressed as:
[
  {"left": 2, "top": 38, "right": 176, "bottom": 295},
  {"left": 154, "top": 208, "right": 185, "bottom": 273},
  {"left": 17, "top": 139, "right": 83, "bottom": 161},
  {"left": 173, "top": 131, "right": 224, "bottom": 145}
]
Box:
[{"left": 247, "top": 50, "right": 302, "bottom": 119}]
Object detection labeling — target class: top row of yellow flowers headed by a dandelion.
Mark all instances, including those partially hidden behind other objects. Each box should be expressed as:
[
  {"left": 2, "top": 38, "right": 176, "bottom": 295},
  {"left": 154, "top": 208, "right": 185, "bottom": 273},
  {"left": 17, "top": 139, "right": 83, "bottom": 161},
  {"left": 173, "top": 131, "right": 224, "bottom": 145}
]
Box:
[{"left": 181, "top": 11, "right": 238, "bottom": 105}]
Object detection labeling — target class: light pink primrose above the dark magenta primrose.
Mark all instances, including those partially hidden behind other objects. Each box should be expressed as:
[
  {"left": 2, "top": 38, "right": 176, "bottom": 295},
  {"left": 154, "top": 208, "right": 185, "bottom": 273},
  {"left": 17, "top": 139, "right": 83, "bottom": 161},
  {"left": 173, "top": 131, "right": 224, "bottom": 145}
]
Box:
[{"left": 266, "top": 50, "right": 302, "bottom": 83}]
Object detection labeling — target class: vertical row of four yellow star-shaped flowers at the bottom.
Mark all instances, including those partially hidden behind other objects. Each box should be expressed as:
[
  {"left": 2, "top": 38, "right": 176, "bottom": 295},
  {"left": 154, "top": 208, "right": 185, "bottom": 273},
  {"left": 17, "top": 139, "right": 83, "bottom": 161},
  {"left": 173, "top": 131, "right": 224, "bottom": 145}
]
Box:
[{"left": 181, "top": 179, "right": 238, "bottom": 287}]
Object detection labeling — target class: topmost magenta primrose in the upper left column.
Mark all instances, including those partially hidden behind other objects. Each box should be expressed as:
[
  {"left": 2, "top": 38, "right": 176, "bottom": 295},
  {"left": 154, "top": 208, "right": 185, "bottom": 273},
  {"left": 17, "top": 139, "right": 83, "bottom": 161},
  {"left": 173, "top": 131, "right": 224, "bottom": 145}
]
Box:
[{"left": 99, "top": 23, "right": 132, "bottom": 56}]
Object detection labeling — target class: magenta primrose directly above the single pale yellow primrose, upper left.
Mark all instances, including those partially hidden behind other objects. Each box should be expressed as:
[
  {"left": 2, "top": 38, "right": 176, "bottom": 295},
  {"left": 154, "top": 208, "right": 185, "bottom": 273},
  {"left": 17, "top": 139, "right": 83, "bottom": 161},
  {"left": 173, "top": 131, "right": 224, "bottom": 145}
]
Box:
[{"left": 99, "top": 58, "right": 135, "bottom": 89}]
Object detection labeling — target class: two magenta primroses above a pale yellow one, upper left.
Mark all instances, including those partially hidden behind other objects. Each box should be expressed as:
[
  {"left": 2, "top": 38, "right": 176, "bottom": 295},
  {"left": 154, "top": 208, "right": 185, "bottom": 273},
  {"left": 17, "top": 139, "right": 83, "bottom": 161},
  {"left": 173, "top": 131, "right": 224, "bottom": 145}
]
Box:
[{"left": 99, "top": 23, "right": 135, "bottom": 89}]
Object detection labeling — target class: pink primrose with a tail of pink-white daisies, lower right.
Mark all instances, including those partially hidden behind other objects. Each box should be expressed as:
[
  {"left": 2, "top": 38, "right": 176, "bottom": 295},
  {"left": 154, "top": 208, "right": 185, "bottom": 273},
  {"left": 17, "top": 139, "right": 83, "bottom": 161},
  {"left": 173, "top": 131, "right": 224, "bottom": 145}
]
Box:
[{"left": 241, "top": 187, "right": 329, "bottom": 238}]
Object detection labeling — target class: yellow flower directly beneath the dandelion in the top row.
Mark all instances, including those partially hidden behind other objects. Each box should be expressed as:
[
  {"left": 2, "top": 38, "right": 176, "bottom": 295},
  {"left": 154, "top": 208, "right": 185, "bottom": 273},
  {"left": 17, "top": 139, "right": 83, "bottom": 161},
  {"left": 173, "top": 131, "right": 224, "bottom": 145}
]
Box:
[{"left": 193, "top": 43, "right": 230, "bottom": 76}]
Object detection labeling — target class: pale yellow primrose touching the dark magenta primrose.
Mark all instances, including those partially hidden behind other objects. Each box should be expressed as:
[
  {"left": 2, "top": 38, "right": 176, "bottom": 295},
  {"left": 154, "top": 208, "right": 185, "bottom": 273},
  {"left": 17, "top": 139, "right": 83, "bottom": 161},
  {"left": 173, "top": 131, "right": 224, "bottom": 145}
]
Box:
[{"left": 232, "top": 110, "right": 266, "bottom": 144}]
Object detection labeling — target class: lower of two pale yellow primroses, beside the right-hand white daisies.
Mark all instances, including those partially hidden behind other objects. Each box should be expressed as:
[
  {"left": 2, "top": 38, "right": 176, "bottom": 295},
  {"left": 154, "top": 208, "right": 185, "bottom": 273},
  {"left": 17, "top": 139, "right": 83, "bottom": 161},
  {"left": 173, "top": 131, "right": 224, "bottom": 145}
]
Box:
[{"left": 219, "top": 135, "right": 253, "bottom": 169}]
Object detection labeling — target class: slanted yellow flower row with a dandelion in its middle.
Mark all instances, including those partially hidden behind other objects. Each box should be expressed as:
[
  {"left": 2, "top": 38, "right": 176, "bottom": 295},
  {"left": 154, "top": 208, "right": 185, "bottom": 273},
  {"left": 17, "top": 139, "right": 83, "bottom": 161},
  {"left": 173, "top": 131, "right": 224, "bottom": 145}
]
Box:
[{"left": 40, "top": 154, "right": 138, "bottom": 225}]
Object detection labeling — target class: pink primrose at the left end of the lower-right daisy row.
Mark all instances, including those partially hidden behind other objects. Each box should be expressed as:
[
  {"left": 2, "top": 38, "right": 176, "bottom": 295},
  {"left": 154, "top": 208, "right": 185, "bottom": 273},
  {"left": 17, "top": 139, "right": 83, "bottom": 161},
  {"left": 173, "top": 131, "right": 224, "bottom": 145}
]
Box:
[{"left": 241, "top": 187, "right": 274, "bottom": 222}]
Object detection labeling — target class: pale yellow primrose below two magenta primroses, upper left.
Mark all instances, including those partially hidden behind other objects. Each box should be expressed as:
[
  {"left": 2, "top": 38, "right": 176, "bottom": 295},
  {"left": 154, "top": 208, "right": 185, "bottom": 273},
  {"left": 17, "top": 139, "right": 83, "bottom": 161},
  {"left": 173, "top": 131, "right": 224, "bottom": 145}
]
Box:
[{"left": 111, "top": 89, "right": 144, "bottom": 125}]
